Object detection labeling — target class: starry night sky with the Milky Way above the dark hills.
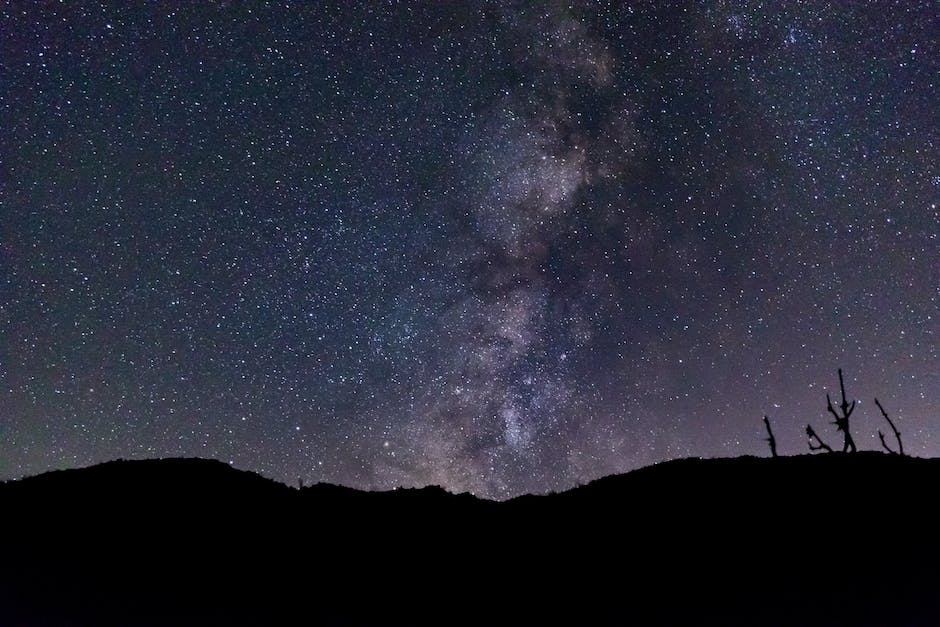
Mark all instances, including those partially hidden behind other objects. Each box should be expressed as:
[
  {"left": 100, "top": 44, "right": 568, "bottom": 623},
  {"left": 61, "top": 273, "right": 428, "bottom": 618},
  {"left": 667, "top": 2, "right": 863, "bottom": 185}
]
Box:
[{"left": 0, "top": 0, "right": 940, "bottom": 498}]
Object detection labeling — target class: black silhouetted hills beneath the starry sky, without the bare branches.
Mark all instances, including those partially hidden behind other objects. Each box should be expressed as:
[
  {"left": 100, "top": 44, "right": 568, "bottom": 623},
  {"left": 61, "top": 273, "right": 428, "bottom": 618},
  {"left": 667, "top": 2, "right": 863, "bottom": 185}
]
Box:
[{"left": 0, "top": 453, "right": 940, "bottom": 627}]
